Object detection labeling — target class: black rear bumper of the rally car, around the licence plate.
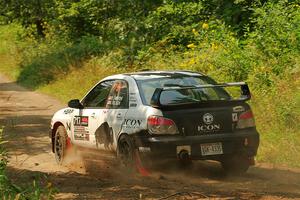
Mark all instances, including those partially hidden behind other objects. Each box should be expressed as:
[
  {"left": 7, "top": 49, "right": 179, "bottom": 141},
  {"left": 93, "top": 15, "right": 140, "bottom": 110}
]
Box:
[{"left": 134, "top": 128, "right": 259, "bottom": 160}]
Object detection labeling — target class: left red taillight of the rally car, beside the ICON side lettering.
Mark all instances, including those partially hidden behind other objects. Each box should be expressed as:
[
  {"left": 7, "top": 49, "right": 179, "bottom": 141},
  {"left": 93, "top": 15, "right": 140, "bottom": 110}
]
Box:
[{"left": 148, "top": 115, "right": 178, "bottom": 134}]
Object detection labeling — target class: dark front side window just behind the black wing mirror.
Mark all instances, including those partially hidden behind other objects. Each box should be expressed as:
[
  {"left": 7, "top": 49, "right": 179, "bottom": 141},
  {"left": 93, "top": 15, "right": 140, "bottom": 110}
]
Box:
[{"left": 82, "top": 80, "right": 114, "bottom": 108}]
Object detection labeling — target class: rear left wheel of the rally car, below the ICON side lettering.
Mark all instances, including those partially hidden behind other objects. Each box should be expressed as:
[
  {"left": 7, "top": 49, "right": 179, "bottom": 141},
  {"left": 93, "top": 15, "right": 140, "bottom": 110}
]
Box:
[{"left": 117, "top": 135, "right": 136, "bottom": 170}]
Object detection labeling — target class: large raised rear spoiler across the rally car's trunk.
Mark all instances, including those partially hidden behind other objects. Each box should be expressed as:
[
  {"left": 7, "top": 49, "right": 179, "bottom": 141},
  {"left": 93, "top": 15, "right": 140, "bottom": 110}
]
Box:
[{"left": 150, "top": 82, "right": 251, "bottom": 107}]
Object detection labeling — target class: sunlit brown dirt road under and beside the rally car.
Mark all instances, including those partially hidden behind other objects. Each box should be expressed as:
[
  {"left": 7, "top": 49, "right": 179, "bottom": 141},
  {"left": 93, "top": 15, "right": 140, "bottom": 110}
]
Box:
[{"left": 0, "top": 75, "right": 300, "bottom": 199}]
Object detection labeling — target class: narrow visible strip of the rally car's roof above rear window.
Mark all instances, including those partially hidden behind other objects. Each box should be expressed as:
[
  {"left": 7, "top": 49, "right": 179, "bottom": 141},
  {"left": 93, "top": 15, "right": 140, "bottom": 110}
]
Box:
[{"left": 124, "top": 70, "right": 204, "bottom": 79}]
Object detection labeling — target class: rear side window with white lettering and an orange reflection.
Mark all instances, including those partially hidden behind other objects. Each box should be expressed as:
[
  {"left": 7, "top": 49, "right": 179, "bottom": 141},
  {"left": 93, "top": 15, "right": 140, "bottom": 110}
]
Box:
[{"left": 106, "top": 80, "right": 128, "bottom": 109}]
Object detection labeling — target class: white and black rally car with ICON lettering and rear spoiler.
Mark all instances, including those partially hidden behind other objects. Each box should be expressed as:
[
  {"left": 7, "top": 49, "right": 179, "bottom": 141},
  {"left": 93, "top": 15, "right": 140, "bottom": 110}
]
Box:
[{"left": 49, "top": 71, "right": 259, "bottom": 172}]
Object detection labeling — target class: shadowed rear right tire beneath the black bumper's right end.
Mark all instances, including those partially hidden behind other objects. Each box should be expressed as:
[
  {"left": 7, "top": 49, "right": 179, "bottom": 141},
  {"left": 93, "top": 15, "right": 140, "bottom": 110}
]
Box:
[{"left": 221, "top": 155, "right": 250, "bottom": 175}]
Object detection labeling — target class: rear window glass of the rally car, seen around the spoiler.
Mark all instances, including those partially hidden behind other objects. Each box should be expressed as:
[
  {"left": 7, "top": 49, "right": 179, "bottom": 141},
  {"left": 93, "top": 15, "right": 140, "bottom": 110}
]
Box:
[{"left": 137, "top": 76, "right": 230, "bottom": 105}]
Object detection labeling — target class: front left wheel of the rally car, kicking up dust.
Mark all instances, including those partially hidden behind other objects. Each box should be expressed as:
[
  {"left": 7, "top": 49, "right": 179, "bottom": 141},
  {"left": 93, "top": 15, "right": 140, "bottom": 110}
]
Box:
[{"left": 54, "top": 125, "right": 67, "bottom": 165}]
